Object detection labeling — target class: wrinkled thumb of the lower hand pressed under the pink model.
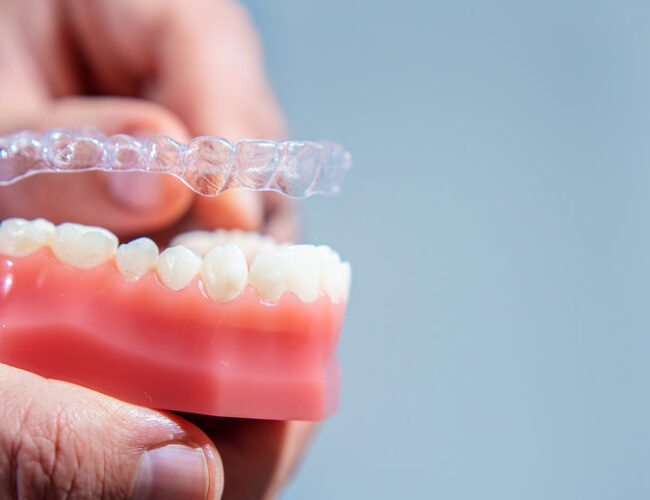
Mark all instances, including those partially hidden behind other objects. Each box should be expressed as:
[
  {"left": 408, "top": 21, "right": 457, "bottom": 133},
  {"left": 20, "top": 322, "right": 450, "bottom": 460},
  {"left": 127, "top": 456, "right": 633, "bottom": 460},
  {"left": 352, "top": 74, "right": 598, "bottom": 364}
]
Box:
[{"left": 0, "top": 365, "right": 223, "bottom": 500}]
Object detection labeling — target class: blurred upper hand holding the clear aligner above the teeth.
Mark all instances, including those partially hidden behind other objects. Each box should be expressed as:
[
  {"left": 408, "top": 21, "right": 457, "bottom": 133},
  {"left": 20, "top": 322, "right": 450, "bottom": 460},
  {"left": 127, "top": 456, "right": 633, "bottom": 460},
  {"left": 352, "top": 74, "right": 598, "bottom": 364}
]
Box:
[{"left": 0, "top": 0, "right": 295, "bottom": 237}]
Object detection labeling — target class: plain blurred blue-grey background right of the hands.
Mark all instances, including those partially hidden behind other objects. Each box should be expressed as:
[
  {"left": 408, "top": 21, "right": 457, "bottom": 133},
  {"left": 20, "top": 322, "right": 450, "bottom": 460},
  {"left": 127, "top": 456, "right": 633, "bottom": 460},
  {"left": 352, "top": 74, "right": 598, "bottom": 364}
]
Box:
[{"left": 246, "top": 0, "right": 650, "bottom": 499}]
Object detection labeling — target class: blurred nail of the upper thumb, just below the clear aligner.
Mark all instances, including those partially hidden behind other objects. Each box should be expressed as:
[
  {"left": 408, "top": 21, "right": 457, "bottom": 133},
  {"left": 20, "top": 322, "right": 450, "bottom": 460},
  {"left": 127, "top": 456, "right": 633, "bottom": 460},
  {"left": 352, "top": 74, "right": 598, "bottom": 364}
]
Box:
[{"left": 106, "top": 172, "right": 163, "bottom": 210}]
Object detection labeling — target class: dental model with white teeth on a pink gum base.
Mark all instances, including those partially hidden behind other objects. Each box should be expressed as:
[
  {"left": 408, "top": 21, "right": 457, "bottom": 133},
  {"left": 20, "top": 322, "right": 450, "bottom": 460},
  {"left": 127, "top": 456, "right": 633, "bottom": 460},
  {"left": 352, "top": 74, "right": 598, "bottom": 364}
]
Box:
[{"left": 0, "top": 132, "right": 350, "bottom": 420}]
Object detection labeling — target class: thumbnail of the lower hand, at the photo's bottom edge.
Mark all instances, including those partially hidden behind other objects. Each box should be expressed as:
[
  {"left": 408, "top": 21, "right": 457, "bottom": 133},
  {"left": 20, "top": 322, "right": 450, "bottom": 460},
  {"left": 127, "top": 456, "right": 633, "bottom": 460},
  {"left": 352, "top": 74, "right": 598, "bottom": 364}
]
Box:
[{"left": 134, "top": 444, "right": 209, "bottom": 500}]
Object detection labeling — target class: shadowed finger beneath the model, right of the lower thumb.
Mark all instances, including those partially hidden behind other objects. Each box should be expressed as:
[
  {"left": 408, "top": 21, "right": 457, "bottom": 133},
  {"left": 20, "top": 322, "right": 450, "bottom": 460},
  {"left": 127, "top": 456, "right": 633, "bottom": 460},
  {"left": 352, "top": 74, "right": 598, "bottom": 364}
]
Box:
[{"left": 180, "top": 413, "right": 317, "bottom": 499}]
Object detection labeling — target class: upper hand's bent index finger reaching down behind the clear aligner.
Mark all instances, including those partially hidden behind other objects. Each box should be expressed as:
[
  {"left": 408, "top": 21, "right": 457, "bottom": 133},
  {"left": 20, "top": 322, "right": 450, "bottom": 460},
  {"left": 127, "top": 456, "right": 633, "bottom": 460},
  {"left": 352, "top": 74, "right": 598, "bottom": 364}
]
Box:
[{"left": 66, "top": 0, "right": 285, "bottom": 230}]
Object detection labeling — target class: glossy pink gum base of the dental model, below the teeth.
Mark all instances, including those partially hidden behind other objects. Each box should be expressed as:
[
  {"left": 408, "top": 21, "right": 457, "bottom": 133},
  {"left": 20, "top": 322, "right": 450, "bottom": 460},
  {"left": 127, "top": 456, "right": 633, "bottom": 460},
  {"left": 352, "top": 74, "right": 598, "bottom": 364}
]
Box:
[{"left": 0, "top": 250, "right": 345, "bottom": 420}]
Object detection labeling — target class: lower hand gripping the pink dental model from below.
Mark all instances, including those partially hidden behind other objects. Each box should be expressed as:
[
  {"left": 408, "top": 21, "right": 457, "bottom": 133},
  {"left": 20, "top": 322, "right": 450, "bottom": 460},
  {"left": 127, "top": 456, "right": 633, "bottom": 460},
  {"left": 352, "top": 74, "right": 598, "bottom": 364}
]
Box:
[{"left": 0, "top": 365, "right": 312, "bottom": 500}]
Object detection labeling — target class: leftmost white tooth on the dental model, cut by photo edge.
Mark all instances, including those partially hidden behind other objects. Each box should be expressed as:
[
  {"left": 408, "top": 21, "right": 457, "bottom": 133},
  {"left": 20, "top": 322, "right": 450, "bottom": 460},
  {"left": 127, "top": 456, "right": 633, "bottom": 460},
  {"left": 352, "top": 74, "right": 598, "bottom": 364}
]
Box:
[{"left": 0, "top": 218, "right": 54, "bottom": 257}]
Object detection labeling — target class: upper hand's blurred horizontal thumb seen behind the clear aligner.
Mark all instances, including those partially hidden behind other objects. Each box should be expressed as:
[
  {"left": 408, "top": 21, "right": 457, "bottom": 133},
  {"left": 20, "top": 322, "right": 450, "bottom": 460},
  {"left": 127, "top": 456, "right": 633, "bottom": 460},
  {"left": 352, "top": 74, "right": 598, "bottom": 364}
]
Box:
[{"left": 0, "top": 98, "right": 192, "bottom": 238}]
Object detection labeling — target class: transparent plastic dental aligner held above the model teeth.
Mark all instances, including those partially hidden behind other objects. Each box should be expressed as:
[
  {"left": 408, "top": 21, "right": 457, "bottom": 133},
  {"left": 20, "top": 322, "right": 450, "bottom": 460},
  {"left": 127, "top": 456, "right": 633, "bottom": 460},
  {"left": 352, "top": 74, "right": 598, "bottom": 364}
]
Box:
[{"left": 0, "top": 128, "right": 351, "bottom": 198}]
